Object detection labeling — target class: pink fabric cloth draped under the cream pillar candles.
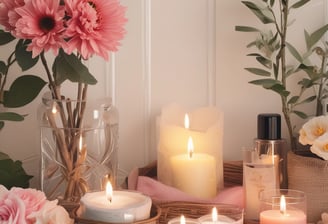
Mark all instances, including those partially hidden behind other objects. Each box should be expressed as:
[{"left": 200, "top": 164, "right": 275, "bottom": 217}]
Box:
[{"left": 128, "top": 170, "right": 244, "bottom": 208}]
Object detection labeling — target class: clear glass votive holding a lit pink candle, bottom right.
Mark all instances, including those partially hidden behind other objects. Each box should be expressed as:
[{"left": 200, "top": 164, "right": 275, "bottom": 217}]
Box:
[{"left": 259, "top": 189, "right": 307, "bottom": 224}]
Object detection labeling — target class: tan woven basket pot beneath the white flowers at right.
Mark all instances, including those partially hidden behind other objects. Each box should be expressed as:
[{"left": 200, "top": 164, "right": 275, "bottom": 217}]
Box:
[{"left": 288, "top": 153, "right": 328, "bottom": 222}]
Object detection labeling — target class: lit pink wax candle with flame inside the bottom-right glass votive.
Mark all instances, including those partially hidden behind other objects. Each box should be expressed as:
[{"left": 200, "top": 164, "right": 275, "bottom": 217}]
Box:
[{"left": 260, "top": 195, "right": 306, "bottom": 224}]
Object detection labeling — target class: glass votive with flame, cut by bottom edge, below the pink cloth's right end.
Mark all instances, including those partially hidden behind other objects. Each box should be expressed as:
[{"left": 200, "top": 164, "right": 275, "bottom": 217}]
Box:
[{"left": 198, "top": 205, "right": 244, "bottom": 224}]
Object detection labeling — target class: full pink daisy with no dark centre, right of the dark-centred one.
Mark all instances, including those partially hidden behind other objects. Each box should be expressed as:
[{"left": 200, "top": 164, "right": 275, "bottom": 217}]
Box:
[{"left": 65, "top": 0, "right": 127, "bottom": 60}]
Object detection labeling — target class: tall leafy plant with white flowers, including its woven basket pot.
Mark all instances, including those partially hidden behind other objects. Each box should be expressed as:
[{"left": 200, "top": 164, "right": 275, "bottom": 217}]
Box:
[{"left": 236, "top": 0, "right": 328, "bottom": 222}]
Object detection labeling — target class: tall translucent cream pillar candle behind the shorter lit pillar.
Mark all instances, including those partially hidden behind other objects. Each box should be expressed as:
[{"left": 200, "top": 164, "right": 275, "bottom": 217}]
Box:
[{"left": 157, "top": 105, "right": 223, "bottom": 190}]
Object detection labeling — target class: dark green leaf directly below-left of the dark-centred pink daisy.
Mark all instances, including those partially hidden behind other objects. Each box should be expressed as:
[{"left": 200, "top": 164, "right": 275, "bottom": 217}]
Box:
[{"left": 15, "top": 40, "right": 39, "bottom": 71}]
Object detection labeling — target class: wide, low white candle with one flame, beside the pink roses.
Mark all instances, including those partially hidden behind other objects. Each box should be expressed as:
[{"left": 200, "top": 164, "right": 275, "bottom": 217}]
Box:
[{"left": 78, "top": 182, "right": 152, "bottom": 223}]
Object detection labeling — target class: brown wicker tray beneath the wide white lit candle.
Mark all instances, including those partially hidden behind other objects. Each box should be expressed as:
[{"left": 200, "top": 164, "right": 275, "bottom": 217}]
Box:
[{"left": 74, "top": 204, "right": 161, "bottom": 224}]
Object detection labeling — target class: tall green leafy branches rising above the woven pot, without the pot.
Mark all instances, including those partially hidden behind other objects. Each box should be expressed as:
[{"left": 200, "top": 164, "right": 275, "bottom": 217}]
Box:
[{"left": 236, "top": 0, "right": 328, "bottom": 150}]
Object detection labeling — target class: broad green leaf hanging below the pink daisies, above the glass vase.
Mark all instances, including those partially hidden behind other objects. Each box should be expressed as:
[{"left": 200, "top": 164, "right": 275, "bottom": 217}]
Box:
[{"left": 52, "top": 50, "right": 97, "bottom": 85}]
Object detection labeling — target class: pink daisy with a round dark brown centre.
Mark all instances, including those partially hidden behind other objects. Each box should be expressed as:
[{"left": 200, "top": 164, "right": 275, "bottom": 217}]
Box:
[{"left": 16, "top": 0, "right": 66, "bottom": 57}]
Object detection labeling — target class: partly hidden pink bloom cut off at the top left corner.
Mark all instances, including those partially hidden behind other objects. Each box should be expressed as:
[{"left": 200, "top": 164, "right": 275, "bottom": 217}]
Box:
[{"left": 0, "top": 0, "right": 25, "bottom": 31}]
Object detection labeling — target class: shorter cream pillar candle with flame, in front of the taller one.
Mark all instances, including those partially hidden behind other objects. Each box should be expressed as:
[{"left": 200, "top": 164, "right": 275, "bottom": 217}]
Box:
[{"left": 171, "top": 138, "right": 217, "bottom": 198}]
